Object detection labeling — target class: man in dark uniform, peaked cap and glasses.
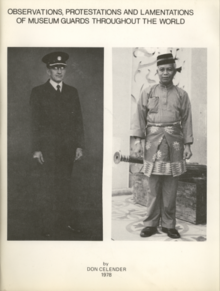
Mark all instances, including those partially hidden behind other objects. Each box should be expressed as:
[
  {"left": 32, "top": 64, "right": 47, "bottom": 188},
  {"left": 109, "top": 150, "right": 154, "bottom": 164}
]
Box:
[{"left": 30, "top": 52, "right": 84, "bottom": 238}]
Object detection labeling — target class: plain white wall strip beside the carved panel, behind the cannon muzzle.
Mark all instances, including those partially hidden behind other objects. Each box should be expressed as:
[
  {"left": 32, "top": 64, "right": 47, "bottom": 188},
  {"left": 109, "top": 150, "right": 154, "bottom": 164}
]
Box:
[{"left": 112, "top": 48, "right": 132, "bottom": 190}]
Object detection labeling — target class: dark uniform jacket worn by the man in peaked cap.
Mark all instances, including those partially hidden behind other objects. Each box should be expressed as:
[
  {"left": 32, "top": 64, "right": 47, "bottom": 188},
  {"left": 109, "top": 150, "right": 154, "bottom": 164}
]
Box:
[{"left": 30, "top": 80, "right": 84, "bottom": 159}]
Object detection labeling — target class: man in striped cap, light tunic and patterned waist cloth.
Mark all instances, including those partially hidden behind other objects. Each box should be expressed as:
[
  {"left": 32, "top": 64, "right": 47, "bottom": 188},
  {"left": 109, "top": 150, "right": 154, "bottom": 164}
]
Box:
[{"left": 132, "top": 53, "right": 193, "bottom": 239}]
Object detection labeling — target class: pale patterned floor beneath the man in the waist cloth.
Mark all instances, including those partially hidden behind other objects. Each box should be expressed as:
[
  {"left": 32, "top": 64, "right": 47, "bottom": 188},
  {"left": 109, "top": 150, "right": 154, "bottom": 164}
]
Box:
[{"left": 112, "top": 195, "right": 206, "bottom": 242}]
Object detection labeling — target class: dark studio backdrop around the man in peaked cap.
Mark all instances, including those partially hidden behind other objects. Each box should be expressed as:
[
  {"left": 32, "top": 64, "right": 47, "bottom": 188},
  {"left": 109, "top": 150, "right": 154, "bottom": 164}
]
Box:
[{"left": 8, "top": 47, "right": 104, "bottom": 240}]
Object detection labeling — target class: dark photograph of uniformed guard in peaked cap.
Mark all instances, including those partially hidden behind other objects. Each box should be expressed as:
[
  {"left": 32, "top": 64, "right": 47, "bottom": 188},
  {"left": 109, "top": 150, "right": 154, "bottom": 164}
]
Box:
[{"left": 7, "top": 47, "right": 104, "bottom": 241}]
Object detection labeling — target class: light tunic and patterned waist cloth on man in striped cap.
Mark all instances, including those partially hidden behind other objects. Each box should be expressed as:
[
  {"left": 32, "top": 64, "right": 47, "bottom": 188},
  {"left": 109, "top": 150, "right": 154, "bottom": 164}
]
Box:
[{"left": 131, "top": 84, "right": 193, "bottom": 177}]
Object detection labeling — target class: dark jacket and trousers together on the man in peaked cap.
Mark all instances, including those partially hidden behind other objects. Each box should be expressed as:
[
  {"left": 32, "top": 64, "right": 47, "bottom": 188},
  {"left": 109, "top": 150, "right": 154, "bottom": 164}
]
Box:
[{"left": 30, "top": 81, "right": 84, "bottom": 227}]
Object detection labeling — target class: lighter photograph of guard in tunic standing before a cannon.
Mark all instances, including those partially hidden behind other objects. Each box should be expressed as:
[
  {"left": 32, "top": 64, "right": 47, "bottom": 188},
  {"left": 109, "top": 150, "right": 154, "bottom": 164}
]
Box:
[{"left": 112, "top": 47, "right": 207, "bottom": 242}]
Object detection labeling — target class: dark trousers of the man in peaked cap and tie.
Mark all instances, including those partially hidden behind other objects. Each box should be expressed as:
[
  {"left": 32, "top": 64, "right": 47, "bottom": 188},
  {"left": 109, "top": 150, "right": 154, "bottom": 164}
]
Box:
[{"left": 32, "top": 148, "right": 77, "bottom": 231}]
